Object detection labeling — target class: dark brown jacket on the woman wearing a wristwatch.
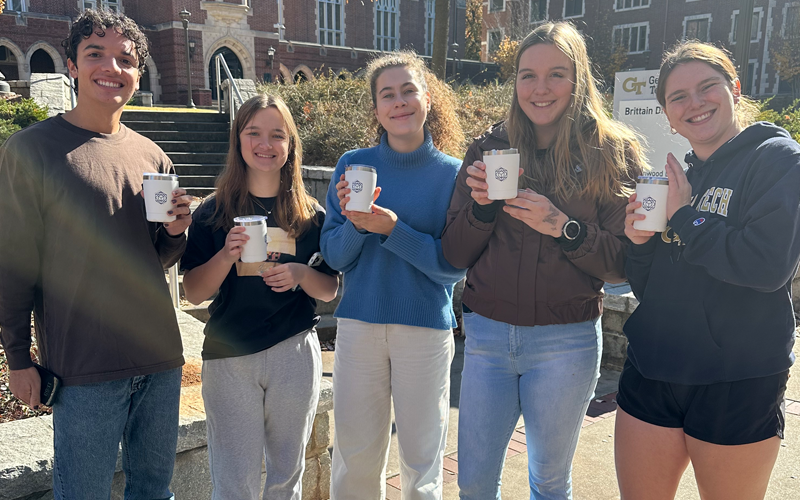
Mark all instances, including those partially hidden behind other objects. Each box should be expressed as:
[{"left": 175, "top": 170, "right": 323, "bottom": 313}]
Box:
[{"left": 442, "top": 124, "right": 628, "bottom": 326}]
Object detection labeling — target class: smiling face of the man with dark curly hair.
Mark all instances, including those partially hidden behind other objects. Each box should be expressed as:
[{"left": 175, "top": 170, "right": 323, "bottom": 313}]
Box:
[{"left": 67, "top": 28, "right": 139, "bottom": 109}]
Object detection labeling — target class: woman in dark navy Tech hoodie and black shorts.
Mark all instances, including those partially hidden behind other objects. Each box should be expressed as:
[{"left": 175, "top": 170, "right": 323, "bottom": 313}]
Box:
[{"left": 615, "top": 42, "right": 800, "bottom": 500}]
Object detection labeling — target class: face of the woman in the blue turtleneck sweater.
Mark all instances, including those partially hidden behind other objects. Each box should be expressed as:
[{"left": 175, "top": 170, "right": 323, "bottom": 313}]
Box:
[{"left": 375, "top": 66, "right": 431, "bottom": 144}]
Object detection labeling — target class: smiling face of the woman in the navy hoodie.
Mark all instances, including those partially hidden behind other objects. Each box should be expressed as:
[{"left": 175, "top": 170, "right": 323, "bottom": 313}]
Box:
[{"left": 664, "top": 61, "right": 741, "bottom": 160}]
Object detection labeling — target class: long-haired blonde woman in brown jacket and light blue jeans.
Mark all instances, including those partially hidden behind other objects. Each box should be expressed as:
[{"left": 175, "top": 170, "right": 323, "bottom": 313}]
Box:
[{"left": 442, "top": 22, "right": 644, "bottom": 500}]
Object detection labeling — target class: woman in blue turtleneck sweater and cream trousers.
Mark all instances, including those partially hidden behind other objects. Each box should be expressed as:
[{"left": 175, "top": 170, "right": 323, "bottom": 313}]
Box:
[{"left": 320, "top": 52, "right": 465, "bottom": 500}]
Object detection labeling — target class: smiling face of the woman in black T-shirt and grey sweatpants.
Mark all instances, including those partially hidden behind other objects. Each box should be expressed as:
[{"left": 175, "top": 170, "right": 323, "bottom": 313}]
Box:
[{"left": 239, "top": 107, "right": 289, "bottom": 182}]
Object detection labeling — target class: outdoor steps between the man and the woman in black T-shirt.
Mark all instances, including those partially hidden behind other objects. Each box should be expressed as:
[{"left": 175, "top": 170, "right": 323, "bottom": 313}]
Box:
[{"left": 122, "top": 110, "right": 229, "bottom": 198}]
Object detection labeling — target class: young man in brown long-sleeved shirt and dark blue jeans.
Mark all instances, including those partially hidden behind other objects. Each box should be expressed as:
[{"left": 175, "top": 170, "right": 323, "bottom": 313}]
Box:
[{"left": 0, "top": 10, "right": 191, "bottom": 500}]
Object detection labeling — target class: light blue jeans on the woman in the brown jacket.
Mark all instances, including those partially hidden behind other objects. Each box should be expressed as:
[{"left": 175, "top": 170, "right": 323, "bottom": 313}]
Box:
[{"left": 458, "top": 312, "right": 602, "bottom": 500}]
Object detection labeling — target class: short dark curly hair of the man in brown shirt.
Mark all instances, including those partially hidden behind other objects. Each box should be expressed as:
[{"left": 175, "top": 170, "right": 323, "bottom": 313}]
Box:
[{"left": 61, "top": 9, "right": 150, "bottom": 93}]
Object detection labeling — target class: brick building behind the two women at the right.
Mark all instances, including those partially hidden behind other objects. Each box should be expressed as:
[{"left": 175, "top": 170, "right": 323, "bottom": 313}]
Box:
[{"left": 481, "top": 0, "right": 800, "bottom": 96}]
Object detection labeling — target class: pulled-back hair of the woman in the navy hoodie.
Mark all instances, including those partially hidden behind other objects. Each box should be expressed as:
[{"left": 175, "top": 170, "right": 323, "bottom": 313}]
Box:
[{"left": 656, "top": 40, "right": 759, "bottom": 128}]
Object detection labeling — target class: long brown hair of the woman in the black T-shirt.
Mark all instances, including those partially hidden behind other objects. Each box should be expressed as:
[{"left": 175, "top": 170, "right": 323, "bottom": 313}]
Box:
[{"left": 212, "top": 94, "right": 317, "bottom": 238}]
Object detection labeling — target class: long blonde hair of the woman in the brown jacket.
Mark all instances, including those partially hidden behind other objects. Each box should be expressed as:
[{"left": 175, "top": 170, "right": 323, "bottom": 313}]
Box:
[{"left": 506, "top": 21, "right": 646, "bottom": 202}]
